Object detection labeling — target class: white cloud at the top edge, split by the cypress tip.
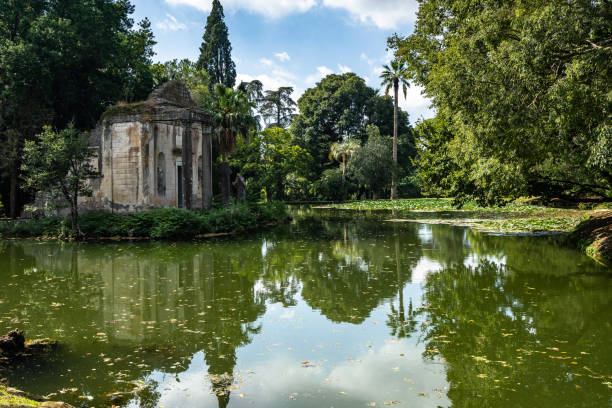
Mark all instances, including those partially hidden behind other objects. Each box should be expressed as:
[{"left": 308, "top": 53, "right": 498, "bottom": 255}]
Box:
[{"left": 166, "top": 0, "right": 317, "bottom": 19}]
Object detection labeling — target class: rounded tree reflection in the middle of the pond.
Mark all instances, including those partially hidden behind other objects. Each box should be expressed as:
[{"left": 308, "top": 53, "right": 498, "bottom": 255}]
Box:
[{"left": 264, "top": 221, "right": 419, "bottom": 324}]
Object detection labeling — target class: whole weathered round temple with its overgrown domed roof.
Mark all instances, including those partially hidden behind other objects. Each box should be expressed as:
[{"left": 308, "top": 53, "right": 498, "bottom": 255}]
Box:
[{"left": 82, "top": 81, "right": 213, "bottom": 213}]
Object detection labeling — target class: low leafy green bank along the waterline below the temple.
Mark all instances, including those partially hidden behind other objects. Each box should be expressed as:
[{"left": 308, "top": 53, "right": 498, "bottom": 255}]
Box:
[{"left": 0, "top": 203, "right": 289, "bottom": 239}]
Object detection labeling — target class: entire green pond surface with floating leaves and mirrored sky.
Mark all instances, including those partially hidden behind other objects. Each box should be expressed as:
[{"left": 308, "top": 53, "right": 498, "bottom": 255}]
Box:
[{"left": 0, "top": 214, "right": 612, "bottom": 408}]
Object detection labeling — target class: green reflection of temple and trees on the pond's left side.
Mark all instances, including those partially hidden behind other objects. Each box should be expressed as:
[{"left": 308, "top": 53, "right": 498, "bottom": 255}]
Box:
[{"left": 0, "top": 242, "right": 265, "bottom": 406}]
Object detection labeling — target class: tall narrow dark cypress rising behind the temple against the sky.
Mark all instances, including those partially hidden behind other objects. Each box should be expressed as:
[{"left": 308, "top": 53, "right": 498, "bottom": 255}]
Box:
[{"left": 198, "top": 0, "right": 236, "bottom": 89}]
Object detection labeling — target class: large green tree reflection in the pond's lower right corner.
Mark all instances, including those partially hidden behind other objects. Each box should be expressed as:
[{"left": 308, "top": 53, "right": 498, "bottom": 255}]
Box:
[{"left": 422, "top": 261, "right": 612, "bottom": 407}]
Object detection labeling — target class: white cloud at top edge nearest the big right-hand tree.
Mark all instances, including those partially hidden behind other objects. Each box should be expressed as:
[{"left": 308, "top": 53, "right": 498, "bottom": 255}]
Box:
[{"left": 322, "top": 0, "right": 418, "bottom": 29}]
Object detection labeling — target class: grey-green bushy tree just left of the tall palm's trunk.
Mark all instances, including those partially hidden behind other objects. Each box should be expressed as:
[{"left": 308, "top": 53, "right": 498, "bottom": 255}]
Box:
[{"left": 349, "top": 126, "right": 396, "bottom": 199}]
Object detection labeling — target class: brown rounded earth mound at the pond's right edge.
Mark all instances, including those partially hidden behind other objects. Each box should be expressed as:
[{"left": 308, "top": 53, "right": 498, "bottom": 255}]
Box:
[{"left": 570, "top": 211, "right": 612, "bottom": 265}]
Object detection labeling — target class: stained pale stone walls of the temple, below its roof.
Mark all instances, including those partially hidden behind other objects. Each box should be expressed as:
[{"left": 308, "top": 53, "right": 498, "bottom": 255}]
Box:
[{"left": 82, "top": 118, "right": 210, "bottom": 213}]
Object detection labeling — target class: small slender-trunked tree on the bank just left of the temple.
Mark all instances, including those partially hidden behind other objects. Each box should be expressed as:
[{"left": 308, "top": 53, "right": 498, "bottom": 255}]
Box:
[{"left": 21, "top": 126, "right": 100, "bottom": 234}]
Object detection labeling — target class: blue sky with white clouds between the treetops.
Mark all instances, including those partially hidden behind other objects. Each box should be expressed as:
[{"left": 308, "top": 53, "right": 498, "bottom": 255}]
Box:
[{"left": 132, "top": 0, "right": 435, "bottom": 123}]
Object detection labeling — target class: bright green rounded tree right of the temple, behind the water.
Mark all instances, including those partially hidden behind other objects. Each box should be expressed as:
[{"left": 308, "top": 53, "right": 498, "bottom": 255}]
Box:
[{"left": 232, "top": 128, "right": 312, "bottom": 201}]
